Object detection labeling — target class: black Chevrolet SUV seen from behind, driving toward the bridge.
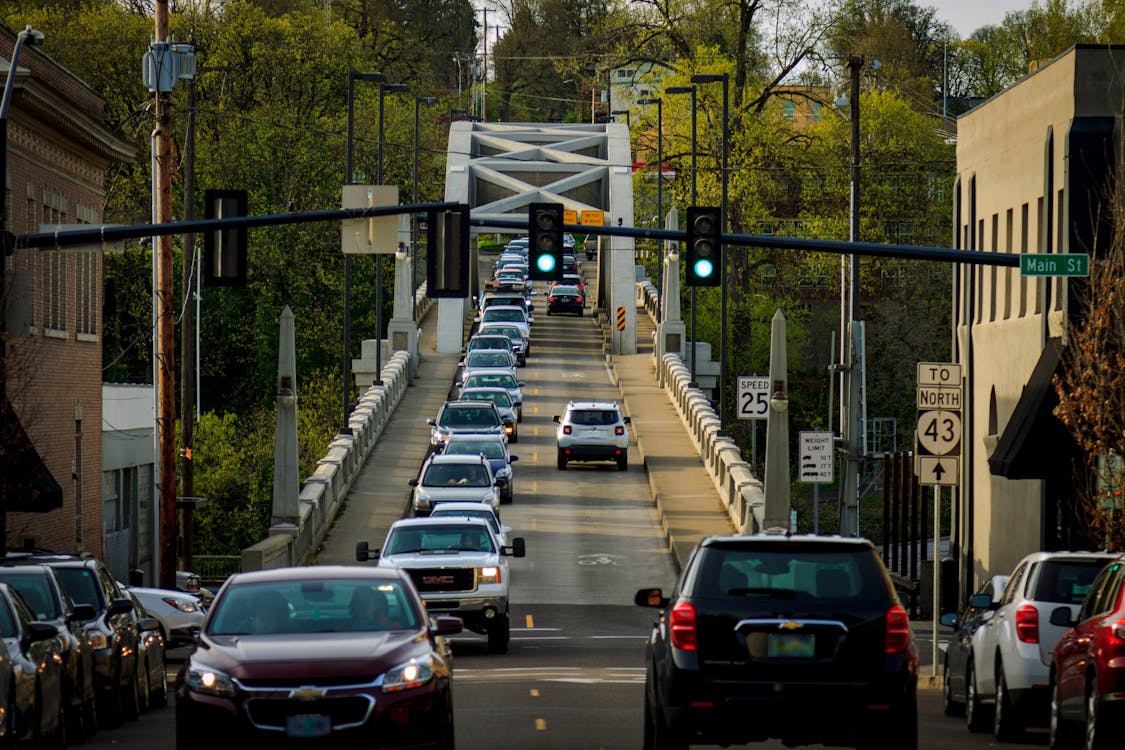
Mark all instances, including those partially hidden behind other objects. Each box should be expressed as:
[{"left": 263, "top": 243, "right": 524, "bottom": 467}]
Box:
[{"left": 636, "top": 534, "right": 918, "bottom": 750}]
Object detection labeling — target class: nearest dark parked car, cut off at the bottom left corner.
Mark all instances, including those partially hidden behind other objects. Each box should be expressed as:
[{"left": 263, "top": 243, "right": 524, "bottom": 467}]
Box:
[{"left": 0, "top": 584, "right": 66, "bottom": 748}]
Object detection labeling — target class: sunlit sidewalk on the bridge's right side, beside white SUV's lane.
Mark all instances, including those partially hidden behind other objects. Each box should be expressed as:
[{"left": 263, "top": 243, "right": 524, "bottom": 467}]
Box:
[{"left": 609, "top": 354, "right": 735, "bottom": 568}]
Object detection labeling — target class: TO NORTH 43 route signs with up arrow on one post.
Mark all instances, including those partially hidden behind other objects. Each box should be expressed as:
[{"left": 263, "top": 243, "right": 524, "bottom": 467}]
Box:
[{"left": 915, "top": 362, "right": 962, "bottom": 486}]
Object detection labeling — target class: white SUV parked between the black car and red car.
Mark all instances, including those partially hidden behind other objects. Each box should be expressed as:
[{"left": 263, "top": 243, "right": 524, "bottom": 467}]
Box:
[{"left": 965, "top": 552, "right": 1117, "bottom": 741}]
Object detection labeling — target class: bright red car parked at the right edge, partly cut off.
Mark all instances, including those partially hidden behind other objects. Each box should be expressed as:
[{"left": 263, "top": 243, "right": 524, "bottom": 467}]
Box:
[{"left": 1051, "top": 557, "right": 1125, "bottom": 750}]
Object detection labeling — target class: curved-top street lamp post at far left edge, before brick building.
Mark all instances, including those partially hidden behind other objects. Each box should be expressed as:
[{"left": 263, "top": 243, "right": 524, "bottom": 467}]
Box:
[{"left": 0, "top": 26, "right": 43, "bottom": 552}]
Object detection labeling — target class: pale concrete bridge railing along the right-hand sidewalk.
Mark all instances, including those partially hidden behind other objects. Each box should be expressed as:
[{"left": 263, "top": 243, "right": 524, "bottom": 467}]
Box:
[{"left": 637, "top": 280, "right": 765, "bottom": 534}]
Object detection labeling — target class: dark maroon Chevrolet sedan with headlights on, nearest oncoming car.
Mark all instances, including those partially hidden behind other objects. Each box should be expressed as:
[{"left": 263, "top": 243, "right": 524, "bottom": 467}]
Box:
[{"left": 176, "top": 566, "right": 462, "bottom": 750}]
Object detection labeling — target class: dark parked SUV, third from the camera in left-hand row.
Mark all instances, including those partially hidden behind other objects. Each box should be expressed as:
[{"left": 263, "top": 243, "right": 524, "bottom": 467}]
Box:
[{"left": 7, "top": 551, "right": 141, "bottom": 726}]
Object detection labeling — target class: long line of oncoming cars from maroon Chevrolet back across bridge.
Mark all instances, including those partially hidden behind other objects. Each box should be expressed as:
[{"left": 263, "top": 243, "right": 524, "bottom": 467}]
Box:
[{"left": 176, "top": 236, "right": 553, "bottom": 750}]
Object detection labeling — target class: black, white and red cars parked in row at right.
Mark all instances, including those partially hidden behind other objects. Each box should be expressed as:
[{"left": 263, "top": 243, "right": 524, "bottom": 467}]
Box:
[{"left": 942, "top": 552, "right": 1125, "bottom": 750}]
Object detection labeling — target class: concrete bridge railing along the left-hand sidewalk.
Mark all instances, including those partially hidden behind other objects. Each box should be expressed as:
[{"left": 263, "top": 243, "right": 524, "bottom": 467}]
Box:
[{"left": 242, "top": 283, "right": 432, "bottom": 570}]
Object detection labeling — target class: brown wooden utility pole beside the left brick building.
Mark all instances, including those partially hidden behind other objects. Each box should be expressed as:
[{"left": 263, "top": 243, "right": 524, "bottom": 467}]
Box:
[{"left": 152, "top": 0, "right": 177, "bottom": 588}]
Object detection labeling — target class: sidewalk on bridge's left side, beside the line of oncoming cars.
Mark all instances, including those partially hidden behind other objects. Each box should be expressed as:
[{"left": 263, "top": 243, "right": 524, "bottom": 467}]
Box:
[{"left": 316, "top": 309, "right": 460, "bottom": 564}]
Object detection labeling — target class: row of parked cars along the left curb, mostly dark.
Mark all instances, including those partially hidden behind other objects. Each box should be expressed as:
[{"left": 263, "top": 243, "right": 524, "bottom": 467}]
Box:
[{"left": 0, "top": 549, "right": 205, "bottom": 748}]
